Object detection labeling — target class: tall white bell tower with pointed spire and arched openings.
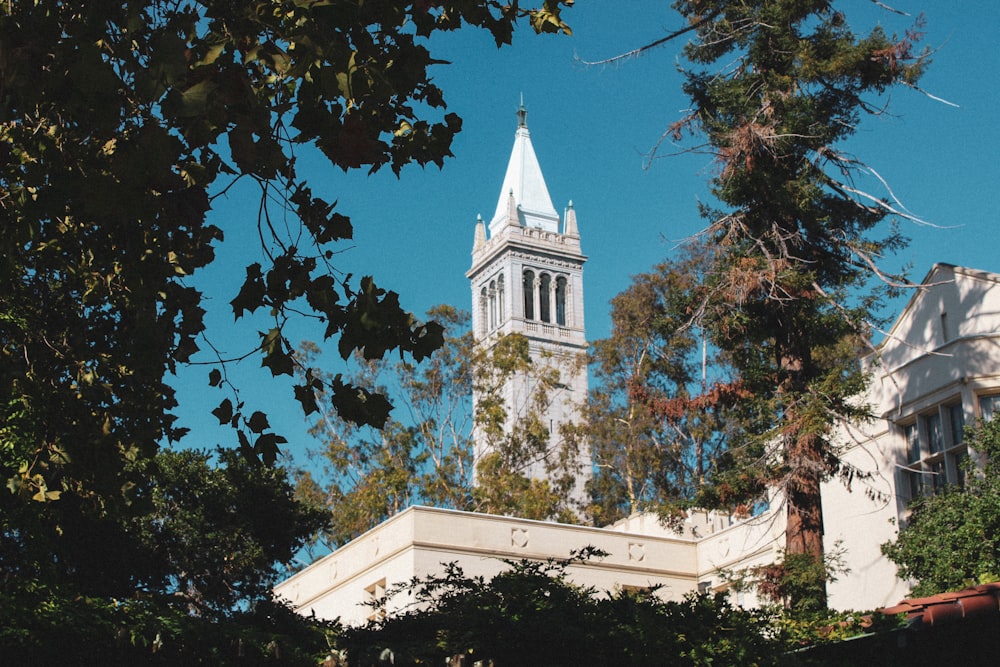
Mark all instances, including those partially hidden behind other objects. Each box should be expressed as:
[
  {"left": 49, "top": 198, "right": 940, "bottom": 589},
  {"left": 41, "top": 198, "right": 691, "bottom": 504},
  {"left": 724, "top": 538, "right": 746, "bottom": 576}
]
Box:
[{"left": 466, "top": 103, "right": 590, "bottom": 501}]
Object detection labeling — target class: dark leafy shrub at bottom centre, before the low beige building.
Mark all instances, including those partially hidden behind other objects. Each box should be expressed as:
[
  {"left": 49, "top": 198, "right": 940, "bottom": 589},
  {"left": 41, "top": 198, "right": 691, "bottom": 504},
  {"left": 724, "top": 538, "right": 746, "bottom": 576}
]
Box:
[{"left": 339, "top": 550, "right": 785, "bottom": 667}]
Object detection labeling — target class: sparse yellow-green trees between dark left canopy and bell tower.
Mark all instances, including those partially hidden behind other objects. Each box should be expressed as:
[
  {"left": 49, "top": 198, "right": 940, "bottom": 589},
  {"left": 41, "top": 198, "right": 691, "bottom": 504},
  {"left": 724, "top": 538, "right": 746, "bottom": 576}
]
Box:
[{"left": 296, "top": 306, "right": 476, "bottom": 548}]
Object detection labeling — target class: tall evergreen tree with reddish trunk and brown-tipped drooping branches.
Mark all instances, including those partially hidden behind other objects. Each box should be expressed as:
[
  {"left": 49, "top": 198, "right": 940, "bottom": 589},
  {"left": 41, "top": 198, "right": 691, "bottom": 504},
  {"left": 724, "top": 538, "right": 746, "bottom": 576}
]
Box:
[{"left": 672, "top": 0, "right": 926, "bottom": 606}]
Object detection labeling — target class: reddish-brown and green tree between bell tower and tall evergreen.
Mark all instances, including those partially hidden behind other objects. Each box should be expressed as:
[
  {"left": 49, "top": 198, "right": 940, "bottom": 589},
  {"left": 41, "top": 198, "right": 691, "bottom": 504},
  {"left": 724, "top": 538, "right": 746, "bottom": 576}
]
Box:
[{"left": 585, "top": 243, "right": 742, "bottom": 525}]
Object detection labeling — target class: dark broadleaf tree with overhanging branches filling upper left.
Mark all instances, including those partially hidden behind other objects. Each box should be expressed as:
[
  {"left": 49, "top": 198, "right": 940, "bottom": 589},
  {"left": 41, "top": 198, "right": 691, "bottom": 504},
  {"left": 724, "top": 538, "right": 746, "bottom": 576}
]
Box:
[{"left": 0, "top": 0, "right": 569, "bottom": 499}]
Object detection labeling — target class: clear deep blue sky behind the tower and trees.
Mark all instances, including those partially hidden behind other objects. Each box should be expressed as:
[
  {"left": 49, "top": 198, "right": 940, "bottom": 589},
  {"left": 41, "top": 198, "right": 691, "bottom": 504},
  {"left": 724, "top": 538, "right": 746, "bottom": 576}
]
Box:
[{"left": 176, "top": 0, "right": 1000, "bottom": 464}]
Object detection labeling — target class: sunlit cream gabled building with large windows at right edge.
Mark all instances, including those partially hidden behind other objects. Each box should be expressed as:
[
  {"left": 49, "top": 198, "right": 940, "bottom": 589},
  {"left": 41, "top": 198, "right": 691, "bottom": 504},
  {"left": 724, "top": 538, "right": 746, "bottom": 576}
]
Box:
[{"left": 823, "top": 264, "right": 1000, "bottom": 609}]
